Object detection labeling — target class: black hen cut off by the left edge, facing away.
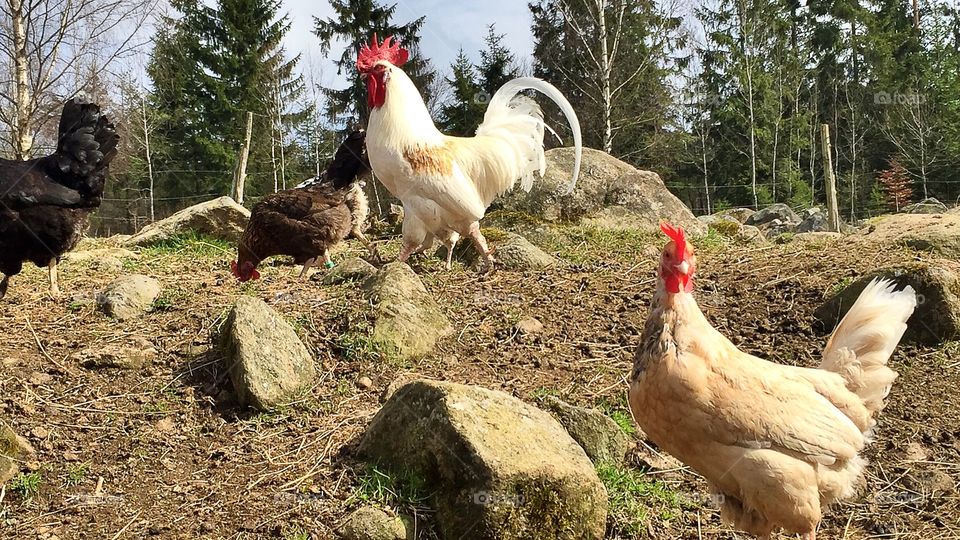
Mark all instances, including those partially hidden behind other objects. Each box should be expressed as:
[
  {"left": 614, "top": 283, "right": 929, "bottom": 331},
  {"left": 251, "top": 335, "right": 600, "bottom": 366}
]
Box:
[{"left": 0, "top": 100, "right": 120, "bottom": 298}]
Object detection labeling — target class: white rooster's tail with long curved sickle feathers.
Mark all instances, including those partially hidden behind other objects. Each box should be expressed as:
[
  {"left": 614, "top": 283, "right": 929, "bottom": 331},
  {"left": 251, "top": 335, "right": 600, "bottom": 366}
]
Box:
[{"left": 477, "top": 77, "right": 583, "bottom": 193}]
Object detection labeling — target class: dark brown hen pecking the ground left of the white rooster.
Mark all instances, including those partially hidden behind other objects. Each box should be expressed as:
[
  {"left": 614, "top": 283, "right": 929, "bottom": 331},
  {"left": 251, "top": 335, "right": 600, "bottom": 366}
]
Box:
[{"left": 232, "top": 130, "right": 371, "bottom": 281}]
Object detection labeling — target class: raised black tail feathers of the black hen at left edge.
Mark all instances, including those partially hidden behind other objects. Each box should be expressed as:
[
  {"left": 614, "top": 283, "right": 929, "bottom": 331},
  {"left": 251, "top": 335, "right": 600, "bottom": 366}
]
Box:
[{"left": 53, "top": 99, "right": 120, "bottom": 197}]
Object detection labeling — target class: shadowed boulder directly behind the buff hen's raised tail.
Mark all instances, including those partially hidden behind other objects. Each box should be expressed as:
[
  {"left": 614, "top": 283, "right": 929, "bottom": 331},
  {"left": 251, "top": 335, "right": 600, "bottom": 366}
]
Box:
[{"left": 814, "top": 261, "right": 960, "bottom": 345}]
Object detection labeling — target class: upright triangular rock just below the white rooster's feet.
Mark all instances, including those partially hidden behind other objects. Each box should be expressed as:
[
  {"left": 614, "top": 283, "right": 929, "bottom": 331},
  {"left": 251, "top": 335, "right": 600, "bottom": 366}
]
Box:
[{"left": 364, "top": 262, "right": 453, "bottom": 359}]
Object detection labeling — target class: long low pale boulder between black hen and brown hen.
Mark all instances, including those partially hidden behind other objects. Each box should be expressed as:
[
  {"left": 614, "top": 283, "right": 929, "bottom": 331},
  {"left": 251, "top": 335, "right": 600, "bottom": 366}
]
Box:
[{"left": 123, "top": 197, "right": 250, "bottom": 246}]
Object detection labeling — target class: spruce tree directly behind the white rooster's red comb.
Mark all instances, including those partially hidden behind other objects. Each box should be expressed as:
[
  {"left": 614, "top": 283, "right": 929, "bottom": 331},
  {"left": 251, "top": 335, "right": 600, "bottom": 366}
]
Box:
[{"left": 313, "top": 0, "right": 436, "bottom": 129}]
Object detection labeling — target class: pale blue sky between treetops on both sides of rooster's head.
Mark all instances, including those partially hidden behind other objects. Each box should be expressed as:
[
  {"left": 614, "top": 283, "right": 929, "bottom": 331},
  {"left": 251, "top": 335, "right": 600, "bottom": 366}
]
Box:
[{"left": 283, "top": 0, "right": 533, "bottom": 85}]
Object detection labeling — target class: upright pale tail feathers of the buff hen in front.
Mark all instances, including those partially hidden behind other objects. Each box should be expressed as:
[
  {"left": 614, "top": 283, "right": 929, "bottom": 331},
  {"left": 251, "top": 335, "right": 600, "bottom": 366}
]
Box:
[{"left": 820, "top": 278, "right": 917, "bottom": 425}]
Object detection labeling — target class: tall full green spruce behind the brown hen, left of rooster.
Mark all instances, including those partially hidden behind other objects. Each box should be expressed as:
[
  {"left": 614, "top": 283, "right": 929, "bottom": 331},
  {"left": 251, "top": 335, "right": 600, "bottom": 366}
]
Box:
[{"left": 147, "top": 0, "right": 308, "bottom": 195}]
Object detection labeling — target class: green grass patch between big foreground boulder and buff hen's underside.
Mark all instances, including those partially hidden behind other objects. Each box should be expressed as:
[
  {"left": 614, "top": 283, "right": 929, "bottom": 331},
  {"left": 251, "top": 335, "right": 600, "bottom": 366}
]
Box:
[{"left": 596, "top": 463, "right": 693, "bottom": 539}]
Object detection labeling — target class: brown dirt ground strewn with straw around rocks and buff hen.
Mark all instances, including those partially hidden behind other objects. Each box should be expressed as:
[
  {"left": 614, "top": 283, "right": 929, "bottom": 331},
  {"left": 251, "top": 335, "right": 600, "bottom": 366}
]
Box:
[{"left": 0, "top": 221, "right": 960, "bottom": 540}]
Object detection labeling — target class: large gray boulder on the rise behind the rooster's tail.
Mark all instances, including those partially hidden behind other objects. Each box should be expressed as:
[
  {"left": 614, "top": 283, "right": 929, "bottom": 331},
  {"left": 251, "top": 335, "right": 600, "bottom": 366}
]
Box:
[{"left": 496, "top": 148, "right": 706, "bottom": 233}]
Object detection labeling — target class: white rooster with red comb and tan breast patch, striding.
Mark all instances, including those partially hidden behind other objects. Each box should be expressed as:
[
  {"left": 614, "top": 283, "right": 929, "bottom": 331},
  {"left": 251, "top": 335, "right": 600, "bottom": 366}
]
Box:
[{"left": 357, "top": 34, "right": 582, "bottom": 269}]
